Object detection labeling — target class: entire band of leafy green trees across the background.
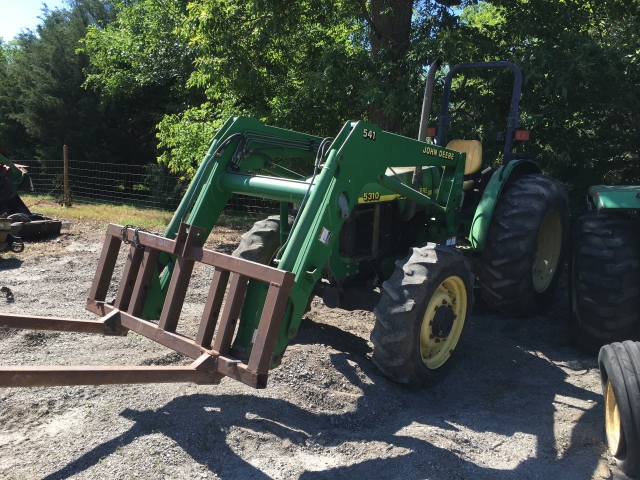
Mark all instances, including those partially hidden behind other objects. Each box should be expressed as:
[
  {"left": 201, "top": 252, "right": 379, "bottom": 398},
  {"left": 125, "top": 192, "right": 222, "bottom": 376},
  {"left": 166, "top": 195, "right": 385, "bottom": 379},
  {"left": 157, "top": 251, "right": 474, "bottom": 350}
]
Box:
[{"left": 0, "top": 0, "right": 640, "bottom": 199}]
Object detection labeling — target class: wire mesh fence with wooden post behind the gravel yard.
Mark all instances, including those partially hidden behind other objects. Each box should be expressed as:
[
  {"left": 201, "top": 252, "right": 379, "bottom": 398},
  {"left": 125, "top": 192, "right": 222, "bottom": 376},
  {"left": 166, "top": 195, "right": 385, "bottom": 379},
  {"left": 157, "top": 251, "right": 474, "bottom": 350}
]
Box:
[{"left": 15, "top": 160, "right": 279, "bottom": 216}]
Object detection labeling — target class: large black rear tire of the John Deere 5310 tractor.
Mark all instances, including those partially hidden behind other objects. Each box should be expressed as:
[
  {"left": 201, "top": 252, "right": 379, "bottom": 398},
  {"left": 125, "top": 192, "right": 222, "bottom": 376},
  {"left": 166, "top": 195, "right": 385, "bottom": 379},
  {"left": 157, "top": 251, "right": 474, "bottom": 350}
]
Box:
[{"left": 479, "top": 174, "right": 569, "bottom": 317}]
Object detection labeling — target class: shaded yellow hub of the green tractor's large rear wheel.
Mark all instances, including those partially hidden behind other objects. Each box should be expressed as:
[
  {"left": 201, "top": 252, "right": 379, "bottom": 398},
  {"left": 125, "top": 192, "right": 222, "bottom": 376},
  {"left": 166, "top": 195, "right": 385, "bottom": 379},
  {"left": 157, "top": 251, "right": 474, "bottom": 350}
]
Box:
[{"left": 531, "top": 210, "right": 562, "bottom": 293}]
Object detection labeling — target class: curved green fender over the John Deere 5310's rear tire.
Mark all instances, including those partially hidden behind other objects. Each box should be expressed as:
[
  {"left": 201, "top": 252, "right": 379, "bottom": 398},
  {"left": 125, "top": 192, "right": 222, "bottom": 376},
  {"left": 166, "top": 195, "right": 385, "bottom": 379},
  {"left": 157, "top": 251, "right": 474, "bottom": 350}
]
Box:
[{"left": 469, "top": 159, "right": 542, "bottom": 252}]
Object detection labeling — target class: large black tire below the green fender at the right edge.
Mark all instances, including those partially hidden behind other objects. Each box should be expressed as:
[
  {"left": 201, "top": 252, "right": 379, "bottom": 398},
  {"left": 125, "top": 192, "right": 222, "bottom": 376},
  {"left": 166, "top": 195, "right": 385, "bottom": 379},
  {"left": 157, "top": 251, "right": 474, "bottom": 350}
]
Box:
[{"left": 569, "top": 210, "right": 640, "bottom": 355}]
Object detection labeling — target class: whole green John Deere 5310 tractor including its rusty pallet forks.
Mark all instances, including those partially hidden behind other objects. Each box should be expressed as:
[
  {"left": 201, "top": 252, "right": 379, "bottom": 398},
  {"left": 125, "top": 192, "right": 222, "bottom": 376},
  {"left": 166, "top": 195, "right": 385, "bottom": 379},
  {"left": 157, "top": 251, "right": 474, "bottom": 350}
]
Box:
[{"left": 0, "top": 62, "right": 568, "bottom": 388}]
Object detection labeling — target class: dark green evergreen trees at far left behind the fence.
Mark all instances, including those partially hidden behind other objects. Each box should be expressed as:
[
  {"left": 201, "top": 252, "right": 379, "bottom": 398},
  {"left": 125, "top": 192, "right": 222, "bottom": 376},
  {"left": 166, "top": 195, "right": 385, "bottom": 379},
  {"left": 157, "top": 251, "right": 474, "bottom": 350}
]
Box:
[{"left": 0, "top": 0, "right": 172, "bottom": 163}]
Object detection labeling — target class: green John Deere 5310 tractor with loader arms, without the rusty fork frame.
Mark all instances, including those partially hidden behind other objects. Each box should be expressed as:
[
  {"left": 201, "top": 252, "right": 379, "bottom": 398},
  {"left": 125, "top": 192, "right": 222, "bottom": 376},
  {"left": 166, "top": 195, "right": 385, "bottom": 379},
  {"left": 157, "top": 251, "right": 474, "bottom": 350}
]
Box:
[{"left": 144, "top": 62, "right": 568, "bottom": 385}]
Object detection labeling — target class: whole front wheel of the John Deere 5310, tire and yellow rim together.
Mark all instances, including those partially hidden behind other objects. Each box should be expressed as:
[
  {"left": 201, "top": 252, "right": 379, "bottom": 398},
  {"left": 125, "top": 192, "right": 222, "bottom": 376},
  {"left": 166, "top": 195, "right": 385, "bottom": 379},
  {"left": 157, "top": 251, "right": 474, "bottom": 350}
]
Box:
[{"left": 371, "top": 243, "right": 473, "bottom": 388}]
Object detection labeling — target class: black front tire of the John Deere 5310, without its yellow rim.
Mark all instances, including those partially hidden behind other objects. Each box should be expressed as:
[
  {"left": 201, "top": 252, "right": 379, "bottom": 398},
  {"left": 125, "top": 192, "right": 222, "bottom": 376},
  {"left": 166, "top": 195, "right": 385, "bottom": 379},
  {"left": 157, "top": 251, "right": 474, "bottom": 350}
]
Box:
[{"left": 371, "top": 243, "right": 473, "bottom": 387}]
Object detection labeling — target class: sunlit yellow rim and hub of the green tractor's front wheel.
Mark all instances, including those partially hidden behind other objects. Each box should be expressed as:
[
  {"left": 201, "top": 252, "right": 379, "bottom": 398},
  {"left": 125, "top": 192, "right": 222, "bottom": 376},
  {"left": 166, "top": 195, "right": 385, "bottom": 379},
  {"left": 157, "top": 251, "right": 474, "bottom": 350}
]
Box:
[{"left": 420, "top": 276, "right": 467, "bottom": 370}]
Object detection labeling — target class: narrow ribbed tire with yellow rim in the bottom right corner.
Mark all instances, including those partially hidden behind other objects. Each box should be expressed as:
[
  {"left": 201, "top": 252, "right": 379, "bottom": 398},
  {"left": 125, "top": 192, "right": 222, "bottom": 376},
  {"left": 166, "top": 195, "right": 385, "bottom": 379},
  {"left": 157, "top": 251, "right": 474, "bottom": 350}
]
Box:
[{"left": 598, "top": 340, "right": 640, "bottom": 477}]
